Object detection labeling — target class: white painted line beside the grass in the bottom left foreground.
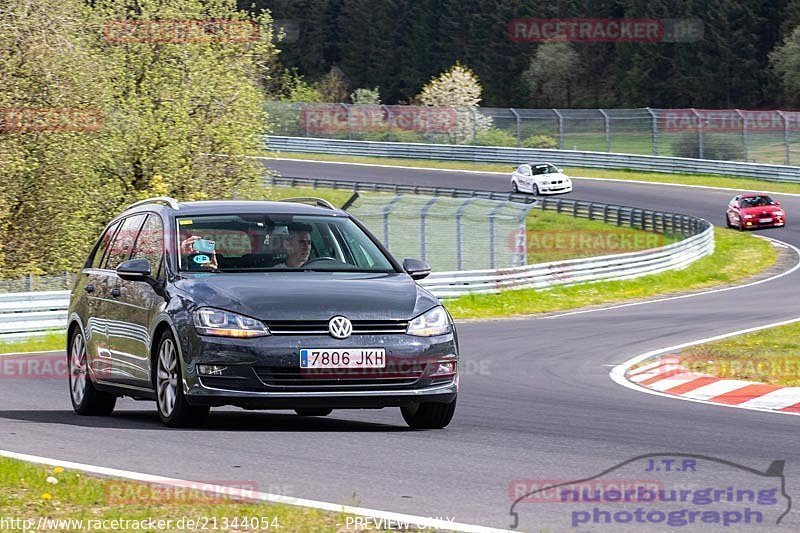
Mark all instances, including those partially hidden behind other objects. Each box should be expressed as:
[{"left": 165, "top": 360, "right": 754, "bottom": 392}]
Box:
[{"left": 0, "top": 450, "right": 508, "bottom": 533}]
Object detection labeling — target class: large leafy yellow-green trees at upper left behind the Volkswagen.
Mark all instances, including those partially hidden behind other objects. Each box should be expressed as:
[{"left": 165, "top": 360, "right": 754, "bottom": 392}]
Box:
[{"left": 0, "top": 0, "right": 277, "bottom": 276}]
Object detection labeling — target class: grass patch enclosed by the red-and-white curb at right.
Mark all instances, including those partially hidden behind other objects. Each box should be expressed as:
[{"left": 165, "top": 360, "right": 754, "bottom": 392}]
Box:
[{"left": 680, "top": 322, "right": 800, "bottom": 387}]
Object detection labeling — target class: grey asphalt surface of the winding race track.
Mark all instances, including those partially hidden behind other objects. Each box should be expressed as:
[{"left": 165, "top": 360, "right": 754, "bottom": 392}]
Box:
[{"left": 0, "top": 161, "right": 800, "bottom": 531}]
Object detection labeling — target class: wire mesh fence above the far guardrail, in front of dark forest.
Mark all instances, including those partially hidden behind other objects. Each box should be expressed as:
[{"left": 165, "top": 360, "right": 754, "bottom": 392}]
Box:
[{"left": 267, "top": 102, "right": 800, "bottom": 165}]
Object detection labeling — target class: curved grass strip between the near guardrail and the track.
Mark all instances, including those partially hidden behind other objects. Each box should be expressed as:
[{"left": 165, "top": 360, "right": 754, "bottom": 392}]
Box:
[{"left": 445, "top": 228, "right": 778, "bottom": 319}]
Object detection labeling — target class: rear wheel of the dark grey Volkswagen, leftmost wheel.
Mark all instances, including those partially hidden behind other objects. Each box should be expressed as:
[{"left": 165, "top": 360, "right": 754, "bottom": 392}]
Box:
[{"left": 67, "top": 329, "right": 117, "bottom": 416}]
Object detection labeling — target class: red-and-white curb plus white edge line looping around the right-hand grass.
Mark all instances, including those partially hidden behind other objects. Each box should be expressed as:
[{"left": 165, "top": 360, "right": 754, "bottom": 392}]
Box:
[{"left": 609, "top": 318, "right": 800, "bottom": 416}]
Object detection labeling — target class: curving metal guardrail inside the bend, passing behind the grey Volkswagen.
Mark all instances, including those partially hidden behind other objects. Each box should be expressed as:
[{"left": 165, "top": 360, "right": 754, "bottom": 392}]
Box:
[{"left": 0, "top": 178, "right": 714, "bottom": 341}]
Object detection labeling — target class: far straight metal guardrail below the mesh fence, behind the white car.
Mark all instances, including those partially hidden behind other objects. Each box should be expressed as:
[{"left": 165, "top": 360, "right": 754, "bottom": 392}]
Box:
[{"left": 267, "top": 135, "right": 800, "bottom": 183}]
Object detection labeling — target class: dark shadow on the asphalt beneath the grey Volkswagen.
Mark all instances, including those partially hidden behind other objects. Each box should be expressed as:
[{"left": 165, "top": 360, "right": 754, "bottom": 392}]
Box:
[{"left": 0, "top": 410, "right": 414, "bottom": 433}]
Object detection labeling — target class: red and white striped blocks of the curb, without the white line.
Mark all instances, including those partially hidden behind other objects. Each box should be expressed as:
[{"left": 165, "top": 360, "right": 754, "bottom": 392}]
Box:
[{"left": 625, "top": 355, "right": 800, "bottom": 414}]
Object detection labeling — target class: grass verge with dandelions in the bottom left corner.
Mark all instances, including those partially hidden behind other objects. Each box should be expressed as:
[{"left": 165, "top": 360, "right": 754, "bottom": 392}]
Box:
[{"left": 0, "top": 457, "right": 396, "bottom": 532}]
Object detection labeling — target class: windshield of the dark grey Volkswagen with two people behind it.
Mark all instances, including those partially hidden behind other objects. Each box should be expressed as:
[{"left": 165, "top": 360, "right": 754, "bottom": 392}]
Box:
[{"left": 177, "top": 214, "right": 395, "bottom": 272}]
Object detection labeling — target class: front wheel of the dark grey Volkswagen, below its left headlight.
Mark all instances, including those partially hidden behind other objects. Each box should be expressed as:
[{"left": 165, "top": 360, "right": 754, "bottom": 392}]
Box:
[{"left": 153, "top": 331, "right": 209, "bottom": 428}]
